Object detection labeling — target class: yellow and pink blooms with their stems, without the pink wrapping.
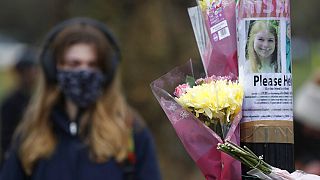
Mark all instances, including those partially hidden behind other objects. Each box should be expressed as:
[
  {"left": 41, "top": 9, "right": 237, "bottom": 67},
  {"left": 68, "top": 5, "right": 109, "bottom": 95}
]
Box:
[{"left": 174, "top": 75, "right": 243, "bottom": 139}]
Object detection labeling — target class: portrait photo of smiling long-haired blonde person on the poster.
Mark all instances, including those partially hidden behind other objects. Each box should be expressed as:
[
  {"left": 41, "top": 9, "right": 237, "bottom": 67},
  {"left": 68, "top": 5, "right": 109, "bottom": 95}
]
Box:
[{"left": 245, "top": 20, "right": 281, "bottom": 73}]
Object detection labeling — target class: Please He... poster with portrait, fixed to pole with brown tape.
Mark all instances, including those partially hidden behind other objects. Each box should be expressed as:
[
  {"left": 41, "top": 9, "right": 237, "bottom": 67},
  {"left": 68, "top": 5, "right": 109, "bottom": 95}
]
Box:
[{"left": 237, "top": 0, "right": 293, "bottom": 143}]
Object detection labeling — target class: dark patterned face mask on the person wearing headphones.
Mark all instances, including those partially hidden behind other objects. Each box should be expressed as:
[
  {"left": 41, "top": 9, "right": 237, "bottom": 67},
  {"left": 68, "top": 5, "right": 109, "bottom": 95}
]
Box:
[{"left": 57, "top": 70, "right": 105, "bottom": 108}]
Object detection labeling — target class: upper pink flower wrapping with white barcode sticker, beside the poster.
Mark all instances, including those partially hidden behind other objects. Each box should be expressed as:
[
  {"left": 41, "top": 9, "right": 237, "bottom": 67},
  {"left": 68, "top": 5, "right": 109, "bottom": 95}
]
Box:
[{"left": 188, "top": 0, "right": 238, "bottom": 76}]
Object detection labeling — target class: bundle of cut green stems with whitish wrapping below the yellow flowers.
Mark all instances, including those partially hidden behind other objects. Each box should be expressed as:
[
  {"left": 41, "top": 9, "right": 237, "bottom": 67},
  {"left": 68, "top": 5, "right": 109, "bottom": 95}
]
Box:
[{"left": 217, "top": 141, "right": 320, "bottom": 180}]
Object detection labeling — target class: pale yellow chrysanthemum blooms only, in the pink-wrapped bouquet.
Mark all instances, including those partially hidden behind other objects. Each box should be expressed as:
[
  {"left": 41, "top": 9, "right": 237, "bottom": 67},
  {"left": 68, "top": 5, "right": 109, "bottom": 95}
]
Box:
[{"left": 176, "top": 80, "right": 243, "bottom": 122}]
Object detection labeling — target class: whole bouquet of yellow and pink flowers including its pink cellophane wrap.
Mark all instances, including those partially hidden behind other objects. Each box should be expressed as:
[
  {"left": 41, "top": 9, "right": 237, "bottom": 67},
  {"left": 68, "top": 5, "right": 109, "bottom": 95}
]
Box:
[{"left": 151, "top": 61, "right": 243, "bottom": 179}]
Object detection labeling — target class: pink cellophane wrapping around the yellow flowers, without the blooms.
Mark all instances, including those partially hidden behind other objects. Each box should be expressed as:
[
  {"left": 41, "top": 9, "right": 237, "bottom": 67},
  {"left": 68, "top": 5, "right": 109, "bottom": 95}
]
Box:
[{"left": 151, "top": 61, "right": 241, "bottom": 179}]
